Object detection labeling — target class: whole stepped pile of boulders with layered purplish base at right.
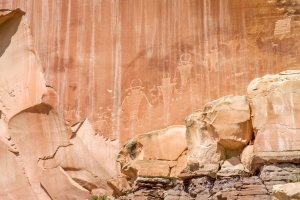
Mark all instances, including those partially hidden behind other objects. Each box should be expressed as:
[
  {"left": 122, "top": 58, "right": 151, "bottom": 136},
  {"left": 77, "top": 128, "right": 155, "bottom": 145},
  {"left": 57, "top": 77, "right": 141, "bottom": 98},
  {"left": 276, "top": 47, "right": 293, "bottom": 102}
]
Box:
[{"left": 111, "top": 70, "right": 300, "bottom": 200}]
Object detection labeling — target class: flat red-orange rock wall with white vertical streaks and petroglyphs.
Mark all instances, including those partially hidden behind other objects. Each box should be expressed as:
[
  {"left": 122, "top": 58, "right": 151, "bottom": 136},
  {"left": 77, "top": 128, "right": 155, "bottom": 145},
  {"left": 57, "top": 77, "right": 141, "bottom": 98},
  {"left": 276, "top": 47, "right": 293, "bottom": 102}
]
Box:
[{"left": 0, "top": 0, "right": 300, "bottom": 144}]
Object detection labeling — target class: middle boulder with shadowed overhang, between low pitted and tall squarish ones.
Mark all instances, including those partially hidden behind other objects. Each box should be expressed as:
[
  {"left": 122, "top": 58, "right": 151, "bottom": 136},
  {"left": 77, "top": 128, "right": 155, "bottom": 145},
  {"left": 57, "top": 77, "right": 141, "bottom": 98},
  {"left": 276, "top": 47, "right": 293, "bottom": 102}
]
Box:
[{"left": 182, "top": 95, "right": 252, "bottom": 177}]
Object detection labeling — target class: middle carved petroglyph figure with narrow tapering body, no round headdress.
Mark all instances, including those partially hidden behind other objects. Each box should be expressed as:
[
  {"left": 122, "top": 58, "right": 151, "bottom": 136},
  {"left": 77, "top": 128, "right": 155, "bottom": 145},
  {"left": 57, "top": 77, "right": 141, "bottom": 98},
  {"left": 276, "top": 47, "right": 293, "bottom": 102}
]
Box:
[{"left": 157, "top": 77, "right": 176, "bottom": 124}]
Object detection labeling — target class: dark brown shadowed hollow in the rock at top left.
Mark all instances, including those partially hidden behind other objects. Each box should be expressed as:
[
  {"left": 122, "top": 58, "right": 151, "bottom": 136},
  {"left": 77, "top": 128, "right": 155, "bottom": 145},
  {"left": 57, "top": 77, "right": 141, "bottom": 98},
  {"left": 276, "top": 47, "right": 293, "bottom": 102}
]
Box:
[{"left": 0, "top": 9, "right": 25, "bottom": 57}]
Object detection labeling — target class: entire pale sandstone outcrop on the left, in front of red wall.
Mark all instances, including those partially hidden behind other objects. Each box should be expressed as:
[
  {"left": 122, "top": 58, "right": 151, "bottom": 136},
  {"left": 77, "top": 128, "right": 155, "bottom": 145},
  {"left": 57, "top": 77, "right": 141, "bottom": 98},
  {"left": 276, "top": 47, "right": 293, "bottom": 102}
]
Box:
[{"left": 0, "top": 9, "right": 119, "bottom": 200}]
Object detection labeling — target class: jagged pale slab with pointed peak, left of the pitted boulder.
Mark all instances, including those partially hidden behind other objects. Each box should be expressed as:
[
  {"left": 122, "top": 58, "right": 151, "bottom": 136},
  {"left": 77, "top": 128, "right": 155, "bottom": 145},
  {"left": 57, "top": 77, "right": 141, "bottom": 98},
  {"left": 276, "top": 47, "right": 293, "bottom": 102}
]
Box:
[{"left": 38, "top": 120, "right": 119, "bottom": 195}]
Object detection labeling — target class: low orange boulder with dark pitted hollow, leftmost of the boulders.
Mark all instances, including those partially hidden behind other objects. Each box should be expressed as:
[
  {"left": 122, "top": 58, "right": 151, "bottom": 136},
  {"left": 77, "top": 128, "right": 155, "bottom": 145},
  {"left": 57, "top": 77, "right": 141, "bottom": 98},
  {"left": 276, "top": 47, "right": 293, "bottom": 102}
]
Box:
[{"left": 117, "top": 126, "right": 187, "bottom": 182}]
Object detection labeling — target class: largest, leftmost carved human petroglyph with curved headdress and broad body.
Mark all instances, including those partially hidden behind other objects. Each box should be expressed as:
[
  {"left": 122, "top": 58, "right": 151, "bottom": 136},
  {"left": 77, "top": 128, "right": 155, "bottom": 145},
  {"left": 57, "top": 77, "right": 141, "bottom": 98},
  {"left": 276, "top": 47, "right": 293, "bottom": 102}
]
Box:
[{"left": 120, "top": 79, "right": 152, "bottom": 130}]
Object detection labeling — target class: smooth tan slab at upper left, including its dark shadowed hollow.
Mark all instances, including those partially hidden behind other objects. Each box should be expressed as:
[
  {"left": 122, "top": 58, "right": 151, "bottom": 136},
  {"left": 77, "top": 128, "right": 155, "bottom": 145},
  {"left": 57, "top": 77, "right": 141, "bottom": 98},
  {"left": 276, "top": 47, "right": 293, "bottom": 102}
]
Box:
[{"left": 0, "top": 10, "right": 46, "bottom": 120}]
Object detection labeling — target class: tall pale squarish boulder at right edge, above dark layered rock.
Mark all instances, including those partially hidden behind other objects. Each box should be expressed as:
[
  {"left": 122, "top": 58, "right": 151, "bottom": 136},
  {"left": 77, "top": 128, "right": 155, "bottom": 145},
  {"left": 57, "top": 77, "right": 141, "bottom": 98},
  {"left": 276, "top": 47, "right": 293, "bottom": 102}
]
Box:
[{"left": 248, "top": 70, "right": 300, "bottom": 168}]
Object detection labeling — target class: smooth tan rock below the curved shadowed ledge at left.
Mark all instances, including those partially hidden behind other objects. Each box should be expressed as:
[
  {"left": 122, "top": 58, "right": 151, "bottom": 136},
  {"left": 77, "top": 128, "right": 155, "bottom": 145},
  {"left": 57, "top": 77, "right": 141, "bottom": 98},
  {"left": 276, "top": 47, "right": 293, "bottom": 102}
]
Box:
[{"left": 8, "top": 103, "right": 72, "bottom": 200}]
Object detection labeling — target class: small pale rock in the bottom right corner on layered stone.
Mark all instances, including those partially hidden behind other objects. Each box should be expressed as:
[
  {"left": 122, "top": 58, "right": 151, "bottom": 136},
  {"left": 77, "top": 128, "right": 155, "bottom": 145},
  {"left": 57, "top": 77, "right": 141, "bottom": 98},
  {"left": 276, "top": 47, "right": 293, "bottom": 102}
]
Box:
[{"left": 272, "top": 182, "right": 300, "bottom": 200}]
